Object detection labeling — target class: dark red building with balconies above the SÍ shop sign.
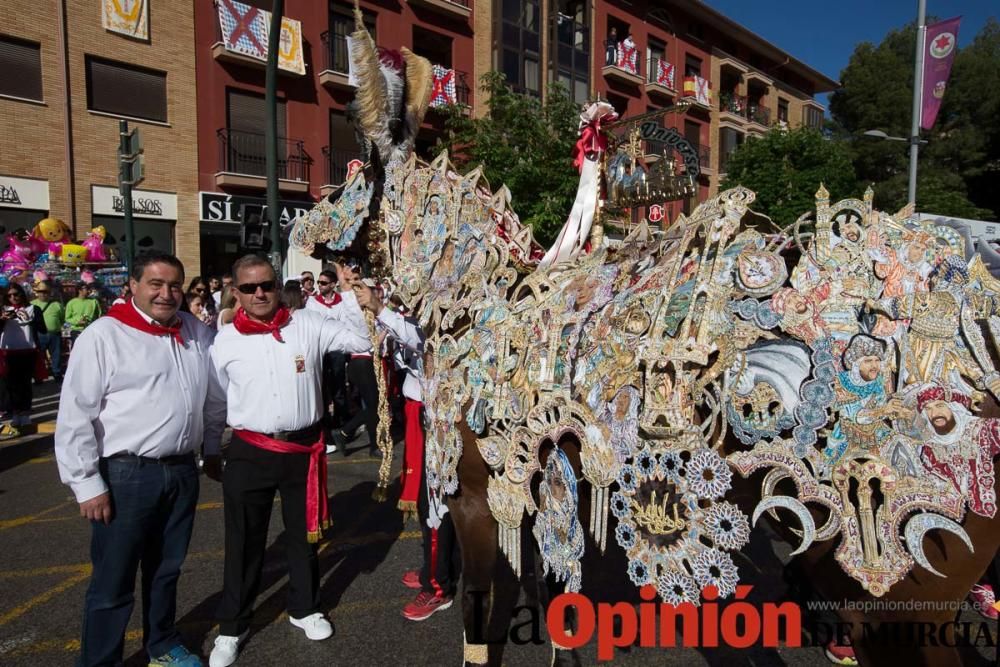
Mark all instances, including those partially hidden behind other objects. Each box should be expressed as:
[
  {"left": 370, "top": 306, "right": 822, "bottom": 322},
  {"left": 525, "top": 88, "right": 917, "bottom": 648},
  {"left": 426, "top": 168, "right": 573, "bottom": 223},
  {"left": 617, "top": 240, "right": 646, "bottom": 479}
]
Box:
[{"left": 194, "top": 0, "right": 476, "bottom": 274}]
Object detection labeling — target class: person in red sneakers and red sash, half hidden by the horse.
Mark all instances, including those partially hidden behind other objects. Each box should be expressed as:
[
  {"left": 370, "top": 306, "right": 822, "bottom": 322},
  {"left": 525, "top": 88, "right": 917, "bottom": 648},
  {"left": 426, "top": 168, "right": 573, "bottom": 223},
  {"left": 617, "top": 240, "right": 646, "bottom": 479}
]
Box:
[{"left": 381, "top": 300, "right": 461, "bottom": 621}]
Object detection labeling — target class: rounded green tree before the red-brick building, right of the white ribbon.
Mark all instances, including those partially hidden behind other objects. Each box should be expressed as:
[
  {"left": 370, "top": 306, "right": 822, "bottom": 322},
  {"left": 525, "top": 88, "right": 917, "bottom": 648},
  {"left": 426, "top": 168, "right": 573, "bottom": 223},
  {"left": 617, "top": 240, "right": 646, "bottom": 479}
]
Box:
[{"left": 721, "top": 128, "right": 861, "bottom": 227}]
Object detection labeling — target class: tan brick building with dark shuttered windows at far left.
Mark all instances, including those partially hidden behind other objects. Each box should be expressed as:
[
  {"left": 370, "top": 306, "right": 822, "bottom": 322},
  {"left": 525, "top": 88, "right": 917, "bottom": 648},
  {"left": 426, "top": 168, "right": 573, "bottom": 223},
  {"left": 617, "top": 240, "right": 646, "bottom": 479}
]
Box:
[{"left": 0, "top": 0, "right": 200, "bottom": 274}]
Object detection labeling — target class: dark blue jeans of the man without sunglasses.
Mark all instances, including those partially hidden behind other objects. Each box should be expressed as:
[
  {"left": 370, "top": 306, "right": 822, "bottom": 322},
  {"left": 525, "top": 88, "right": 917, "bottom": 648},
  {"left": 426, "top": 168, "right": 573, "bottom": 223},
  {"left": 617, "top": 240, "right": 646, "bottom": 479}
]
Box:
[{"left": 77, "top": 455, "right": 198, "bottom": 667}]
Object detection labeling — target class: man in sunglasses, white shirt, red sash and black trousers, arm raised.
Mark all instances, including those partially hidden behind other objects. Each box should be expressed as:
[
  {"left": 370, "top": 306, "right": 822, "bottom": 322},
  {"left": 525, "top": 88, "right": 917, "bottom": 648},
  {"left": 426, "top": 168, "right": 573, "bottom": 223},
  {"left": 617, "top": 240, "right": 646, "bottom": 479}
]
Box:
[{"left": 209, "top": 256, "right": 406, "bottom": 667}]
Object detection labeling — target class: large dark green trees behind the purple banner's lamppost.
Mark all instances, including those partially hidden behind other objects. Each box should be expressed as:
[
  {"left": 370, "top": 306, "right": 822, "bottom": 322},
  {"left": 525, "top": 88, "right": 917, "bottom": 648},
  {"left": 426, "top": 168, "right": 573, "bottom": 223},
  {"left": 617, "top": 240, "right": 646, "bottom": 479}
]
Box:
[{"left": 830, "top": 19, "right": 1000, "bottom": 219}]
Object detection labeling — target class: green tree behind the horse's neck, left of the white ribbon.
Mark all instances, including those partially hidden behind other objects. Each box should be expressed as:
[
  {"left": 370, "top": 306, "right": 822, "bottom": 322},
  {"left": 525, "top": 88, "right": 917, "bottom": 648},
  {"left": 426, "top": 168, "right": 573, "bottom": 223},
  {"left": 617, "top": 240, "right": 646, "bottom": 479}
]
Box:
[{"left": 437, "top": 72, "right": 580, "bottom": 246}]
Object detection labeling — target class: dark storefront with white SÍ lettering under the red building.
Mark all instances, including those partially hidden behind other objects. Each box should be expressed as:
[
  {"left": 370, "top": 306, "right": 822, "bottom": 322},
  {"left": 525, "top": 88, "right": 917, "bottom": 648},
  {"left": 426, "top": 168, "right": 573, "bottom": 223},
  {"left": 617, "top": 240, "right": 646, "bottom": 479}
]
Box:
[{"left": 198, "top": 192, "right": 316, "bottom": 276}]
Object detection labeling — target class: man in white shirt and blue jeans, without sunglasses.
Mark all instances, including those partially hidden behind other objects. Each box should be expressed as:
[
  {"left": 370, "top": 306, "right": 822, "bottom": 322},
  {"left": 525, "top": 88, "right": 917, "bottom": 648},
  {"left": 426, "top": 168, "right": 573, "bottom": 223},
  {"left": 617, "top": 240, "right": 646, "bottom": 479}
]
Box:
[{"left": 55, "top": 254, "right": 226, "bottom": 667}]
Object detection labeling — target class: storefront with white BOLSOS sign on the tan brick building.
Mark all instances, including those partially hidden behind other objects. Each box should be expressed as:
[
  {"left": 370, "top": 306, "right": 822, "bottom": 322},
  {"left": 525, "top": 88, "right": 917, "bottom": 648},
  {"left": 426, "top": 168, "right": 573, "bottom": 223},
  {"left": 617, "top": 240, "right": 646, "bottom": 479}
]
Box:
[{"left": 91, "top": 185, "right": 177, "bottom": 257}]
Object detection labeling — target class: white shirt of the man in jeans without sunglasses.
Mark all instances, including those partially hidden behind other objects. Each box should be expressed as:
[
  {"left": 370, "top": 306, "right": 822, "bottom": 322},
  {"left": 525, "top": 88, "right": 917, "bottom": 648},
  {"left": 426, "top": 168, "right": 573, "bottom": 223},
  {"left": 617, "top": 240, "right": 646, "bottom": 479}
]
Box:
[{"left": 55, "top": 306, "right": 226, "bottom": 503}]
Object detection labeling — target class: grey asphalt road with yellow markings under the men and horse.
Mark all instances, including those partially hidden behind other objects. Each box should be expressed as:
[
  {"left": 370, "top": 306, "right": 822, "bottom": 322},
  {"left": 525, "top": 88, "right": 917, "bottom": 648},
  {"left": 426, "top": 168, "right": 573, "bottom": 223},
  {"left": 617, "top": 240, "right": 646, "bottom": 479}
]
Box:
[{"left": 0, "top": 383, "right": 992, "bottom": 667}]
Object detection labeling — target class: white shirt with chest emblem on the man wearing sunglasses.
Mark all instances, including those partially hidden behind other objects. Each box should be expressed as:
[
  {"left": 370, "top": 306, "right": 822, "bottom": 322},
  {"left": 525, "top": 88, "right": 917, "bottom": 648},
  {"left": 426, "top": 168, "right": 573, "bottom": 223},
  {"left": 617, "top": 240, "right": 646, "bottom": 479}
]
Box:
[{"left": 212, "top": 294, "right": 398, "bottom": 433}]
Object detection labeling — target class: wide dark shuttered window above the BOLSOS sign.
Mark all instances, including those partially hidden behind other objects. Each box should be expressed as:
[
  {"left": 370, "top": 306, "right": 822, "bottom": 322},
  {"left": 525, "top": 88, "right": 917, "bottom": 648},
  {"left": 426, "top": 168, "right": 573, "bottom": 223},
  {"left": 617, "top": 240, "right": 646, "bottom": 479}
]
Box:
[{"left": 87, "top": 57, "right": 167, "bottom": 123}]
